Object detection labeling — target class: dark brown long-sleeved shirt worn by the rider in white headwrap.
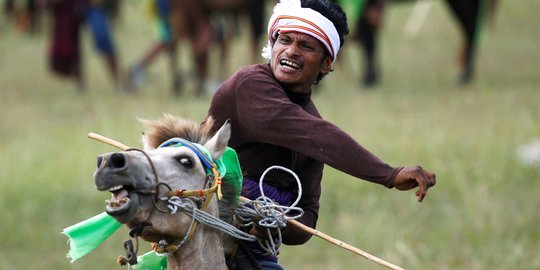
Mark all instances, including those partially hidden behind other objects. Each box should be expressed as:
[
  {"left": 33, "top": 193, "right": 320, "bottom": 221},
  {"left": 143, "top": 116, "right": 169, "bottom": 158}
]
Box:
[{"left": 208, "top": 64, "right": 400, "bottom": 245}]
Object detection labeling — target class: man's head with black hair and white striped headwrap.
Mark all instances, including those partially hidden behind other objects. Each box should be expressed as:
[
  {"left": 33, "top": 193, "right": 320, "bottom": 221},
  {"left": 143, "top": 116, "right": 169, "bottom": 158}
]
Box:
[{"left": 263, "top": 0, "right": 349, "bottom": 88}]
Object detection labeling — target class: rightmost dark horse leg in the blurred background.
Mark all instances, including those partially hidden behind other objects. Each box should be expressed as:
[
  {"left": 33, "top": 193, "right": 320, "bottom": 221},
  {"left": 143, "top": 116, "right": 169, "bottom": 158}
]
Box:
[{"left": 446, "top": 0, "right": 480, "bottom": 85}]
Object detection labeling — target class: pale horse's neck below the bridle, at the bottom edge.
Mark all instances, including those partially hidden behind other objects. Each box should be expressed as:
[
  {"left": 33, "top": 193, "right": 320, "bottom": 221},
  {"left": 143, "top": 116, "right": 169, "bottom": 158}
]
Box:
[{"left": 167, "top": 211, "right": 227, "bottom": 270}]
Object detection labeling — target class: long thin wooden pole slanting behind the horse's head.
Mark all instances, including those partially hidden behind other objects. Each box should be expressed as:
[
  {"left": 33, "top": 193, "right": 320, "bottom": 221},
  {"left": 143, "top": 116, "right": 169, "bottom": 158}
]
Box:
[{"left": 88, "top": 132, "right": 404, "bottom": 270}]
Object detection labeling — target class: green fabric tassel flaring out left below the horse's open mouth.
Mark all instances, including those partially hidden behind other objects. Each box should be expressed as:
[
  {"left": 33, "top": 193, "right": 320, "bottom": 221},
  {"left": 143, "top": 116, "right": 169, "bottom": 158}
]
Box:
[{"left": 62, "top": 212, "right": 121, "bottom": 262}]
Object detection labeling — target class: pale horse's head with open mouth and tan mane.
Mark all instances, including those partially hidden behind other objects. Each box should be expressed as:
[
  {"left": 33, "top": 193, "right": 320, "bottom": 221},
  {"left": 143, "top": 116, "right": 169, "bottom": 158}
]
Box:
[{"left": 94, "top": 116, "right": 230, "bottom": 243}]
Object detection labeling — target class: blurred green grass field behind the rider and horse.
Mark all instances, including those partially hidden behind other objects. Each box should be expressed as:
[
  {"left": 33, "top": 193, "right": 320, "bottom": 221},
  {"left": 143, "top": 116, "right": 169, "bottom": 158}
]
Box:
[{"left": 0, "top": 0, "right": 540, "bottom": 270}]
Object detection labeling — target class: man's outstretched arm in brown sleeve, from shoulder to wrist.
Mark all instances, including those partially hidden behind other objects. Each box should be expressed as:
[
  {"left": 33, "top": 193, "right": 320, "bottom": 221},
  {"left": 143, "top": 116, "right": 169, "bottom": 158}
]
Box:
[{"left": 237, "top": 80, "right": 397, "bottom": 187}]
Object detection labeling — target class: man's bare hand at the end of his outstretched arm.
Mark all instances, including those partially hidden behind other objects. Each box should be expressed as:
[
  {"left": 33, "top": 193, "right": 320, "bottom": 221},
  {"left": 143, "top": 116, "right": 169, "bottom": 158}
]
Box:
[{"left": 394, "top": 166, "right": 436, "bottom": 202}]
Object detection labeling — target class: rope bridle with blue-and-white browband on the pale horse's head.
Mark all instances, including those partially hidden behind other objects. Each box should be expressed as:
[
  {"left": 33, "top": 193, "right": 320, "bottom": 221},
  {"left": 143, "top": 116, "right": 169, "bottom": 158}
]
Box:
[{"left": 119, "top": 138, "right": 223, "bottom": 264}]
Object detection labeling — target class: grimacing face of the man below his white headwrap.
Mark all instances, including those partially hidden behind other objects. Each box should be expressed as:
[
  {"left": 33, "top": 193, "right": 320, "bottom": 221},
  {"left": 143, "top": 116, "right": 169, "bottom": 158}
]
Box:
[{"left": 270, "top": 32, "right": 332, "bottom": 93}]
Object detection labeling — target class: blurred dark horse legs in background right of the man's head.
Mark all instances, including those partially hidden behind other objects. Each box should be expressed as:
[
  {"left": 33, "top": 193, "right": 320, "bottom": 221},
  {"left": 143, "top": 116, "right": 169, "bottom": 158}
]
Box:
[{"left": 355, "top": 0, "right": 497, "bottom": 87}]
